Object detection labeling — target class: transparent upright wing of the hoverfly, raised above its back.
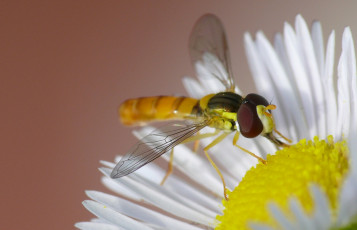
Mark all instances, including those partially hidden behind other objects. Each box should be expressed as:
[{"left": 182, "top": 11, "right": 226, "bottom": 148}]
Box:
[{"left": 189, "top": 14, "right": 235, "bottom": 91}]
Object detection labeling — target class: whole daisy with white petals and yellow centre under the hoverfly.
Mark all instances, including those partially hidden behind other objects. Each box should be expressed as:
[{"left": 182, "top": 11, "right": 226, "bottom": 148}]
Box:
[{"left": 75, "top": 15, "right": 357, "bottom": 230}]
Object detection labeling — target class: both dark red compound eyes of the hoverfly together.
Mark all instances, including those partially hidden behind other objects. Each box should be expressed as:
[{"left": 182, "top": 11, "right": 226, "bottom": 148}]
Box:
[{"left": 237, "top": 93, "right": 269, "bottom": 138}]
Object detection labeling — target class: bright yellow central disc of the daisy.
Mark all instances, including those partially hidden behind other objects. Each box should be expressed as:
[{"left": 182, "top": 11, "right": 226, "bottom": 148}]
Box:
[{"left": 216, "top": 136, "right": 348, "bottom": 230}]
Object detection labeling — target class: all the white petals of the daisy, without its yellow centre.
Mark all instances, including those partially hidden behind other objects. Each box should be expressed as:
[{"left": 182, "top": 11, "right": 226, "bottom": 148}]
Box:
[{"left": 76, "top": 15, "right": 357, "bottom": 229}]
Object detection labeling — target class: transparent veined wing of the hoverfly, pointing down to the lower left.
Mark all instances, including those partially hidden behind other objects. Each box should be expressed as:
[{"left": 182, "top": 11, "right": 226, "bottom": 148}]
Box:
[{"left": 110, "top": 121, "right": 208, "bottom": 178}]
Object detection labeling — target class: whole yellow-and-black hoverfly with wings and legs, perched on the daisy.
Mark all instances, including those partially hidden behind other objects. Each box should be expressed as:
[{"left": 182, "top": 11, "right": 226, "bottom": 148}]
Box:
[{"left": 111, "top": 14, "right": 290, "bottom": 199}]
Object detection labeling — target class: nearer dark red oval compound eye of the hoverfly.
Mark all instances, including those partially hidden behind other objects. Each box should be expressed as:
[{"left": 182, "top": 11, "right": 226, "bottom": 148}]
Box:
[{"left": 237, "top": 101, "right": 263, "bottom": 138}]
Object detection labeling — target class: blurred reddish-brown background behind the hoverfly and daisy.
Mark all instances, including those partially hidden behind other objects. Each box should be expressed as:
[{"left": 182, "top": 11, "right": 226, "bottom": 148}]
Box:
[{"left": 0, "top": 0, "right": 357, "bottom": 229}]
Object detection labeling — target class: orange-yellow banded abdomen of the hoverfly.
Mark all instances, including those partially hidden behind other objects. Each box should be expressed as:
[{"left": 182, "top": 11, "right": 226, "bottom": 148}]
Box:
[{"left": 119, "top": 96, "right": 199, "bottom": 125}]
